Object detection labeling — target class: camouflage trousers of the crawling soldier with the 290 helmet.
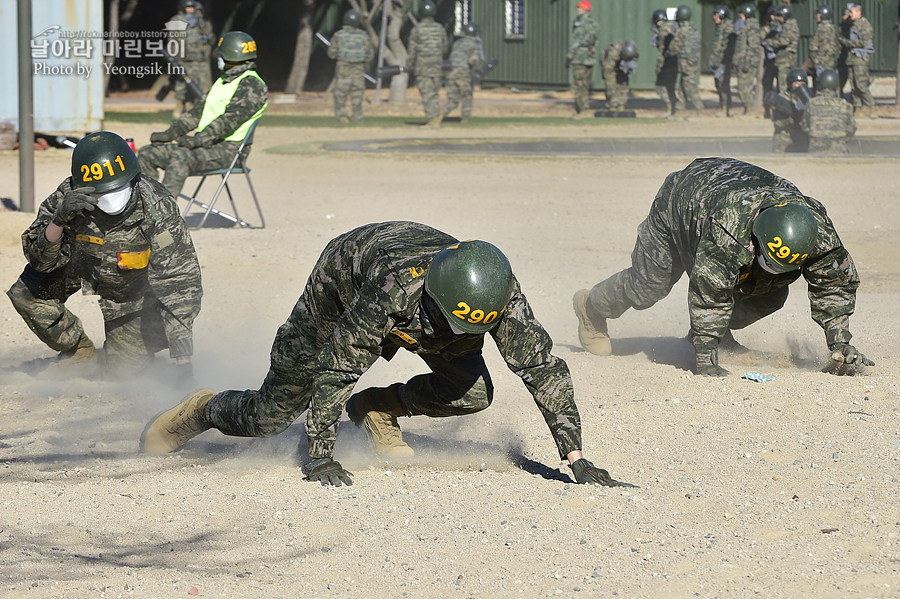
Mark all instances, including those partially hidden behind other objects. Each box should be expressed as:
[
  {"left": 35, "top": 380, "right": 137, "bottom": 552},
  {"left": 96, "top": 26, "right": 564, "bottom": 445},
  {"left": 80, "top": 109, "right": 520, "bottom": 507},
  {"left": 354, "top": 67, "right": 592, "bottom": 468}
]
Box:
[{"left": 207, "top": 297, "right": 494, "bottom": 458}]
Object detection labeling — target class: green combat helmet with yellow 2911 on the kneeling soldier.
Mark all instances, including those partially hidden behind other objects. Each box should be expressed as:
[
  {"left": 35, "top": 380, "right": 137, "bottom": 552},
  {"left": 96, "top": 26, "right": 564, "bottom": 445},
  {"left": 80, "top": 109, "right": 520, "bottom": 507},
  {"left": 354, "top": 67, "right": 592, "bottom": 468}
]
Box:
[{"left": 72, "top": 131, "right": 141, "bottom": 194}]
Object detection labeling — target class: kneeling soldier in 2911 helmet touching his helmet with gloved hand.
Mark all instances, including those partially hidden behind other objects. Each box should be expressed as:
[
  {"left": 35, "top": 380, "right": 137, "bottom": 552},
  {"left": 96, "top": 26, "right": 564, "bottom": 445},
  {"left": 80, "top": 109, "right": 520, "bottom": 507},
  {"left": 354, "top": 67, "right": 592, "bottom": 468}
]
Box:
[{"left": 7, "top": 131, "right": 202, "bottom": 378}]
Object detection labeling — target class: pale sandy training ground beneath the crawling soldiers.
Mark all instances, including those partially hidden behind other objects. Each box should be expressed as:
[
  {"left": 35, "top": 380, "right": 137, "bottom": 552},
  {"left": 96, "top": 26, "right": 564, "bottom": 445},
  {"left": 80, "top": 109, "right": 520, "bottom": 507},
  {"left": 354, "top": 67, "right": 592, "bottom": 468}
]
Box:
[{"left": 0, "top": 90, "right": 900, "bottom": 599}]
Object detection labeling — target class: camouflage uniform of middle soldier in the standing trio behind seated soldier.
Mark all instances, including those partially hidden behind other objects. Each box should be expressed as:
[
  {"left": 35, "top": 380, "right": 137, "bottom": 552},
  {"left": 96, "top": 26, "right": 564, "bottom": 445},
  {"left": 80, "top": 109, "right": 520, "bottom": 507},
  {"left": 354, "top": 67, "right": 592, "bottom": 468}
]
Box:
[{"left": 406, "top": 17, "right": 450, "bottom": 120}]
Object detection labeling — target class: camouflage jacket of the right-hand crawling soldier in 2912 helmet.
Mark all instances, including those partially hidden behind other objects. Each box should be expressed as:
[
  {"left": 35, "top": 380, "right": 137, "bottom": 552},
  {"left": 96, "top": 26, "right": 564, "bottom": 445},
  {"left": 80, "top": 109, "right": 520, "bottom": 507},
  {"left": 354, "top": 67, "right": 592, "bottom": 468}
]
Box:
[{"left": 652, "top": 158, "right": 859, "bottom": 355}]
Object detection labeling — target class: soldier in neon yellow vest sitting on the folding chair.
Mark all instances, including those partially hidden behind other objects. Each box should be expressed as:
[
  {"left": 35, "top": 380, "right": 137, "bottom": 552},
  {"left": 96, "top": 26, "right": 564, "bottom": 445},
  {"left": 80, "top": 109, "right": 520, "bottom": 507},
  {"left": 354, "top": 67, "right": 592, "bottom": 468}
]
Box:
[{"left": 138, "top": 31, "right": 269, "bottom": 197}]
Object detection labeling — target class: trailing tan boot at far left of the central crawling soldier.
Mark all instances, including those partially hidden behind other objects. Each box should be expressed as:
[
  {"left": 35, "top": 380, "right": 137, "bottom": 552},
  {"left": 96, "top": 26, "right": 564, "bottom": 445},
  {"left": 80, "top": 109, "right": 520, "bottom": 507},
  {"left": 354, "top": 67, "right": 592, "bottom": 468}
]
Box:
[{"left": 140, "top": 389, "right": 216, "bottom": 455}]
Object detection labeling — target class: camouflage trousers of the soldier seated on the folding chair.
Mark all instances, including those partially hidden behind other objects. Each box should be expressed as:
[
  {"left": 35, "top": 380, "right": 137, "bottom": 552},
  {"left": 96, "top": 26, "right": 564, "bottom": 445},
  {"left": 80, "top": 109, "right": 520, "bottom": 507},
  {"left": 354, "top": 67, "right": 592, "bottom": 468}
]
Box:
[{"left": 138, "top": 141, "right": 240, "bottom": 198}]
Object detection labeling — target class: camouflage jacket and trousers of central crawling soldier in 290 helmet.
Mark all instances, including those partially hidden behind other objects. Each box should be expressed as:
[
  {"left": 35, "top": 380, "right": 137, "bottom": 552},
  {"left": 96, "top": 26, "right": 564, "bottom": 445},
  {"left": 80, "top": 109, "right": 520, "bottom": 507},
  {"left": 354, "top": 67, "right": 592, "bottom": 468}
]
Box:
[{"left": 206, "top": 222, "right": 581, "bottom": 459}]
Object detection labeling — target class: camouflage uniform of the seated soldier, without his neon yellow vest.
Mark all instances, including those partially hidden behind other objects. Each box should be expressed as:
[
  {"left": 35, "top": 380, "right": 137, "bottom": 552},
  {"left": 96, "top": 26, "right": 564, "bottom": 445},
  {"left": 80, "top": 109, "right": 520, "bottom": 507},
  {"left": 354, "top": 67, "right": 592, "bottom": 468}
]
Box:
[{"left": 138, "top": 62, "right": 269, "bottom": 197}]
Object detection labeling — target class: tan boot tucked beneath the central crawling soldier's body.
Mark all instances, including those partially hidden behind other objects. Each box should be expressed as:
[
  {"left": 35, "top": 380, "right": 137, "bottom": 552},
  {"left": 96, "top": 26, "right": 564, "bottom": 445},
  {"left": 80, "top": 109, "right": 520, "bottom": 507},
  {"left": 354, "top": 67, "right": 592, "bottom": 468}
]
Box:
[{"left": 347, "top": 386, "right": 415, "bottom": 458}]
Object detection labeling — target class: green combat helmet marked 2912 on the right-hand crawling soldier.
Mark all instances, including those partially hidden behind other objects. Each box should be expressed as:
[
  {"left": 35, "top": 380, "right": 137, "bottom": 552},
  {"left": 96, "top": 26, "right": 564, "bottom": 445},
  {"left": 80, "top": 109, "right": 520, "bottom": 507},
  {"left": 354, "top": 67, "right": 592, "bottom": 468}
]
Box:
[{"left": 753, "top": 202, "right": 818, "bottom": 272}]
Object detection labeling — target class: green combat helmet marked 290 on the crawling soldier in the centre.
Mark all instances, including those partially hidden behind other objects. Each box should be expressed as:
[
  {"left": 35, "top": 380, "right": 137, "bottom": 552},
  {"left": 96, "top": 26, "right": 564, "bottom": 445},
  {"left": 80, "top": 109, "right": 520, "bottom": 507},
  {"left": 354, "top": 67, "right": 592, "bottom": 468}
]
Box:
[{"left": 425, "top": 241, "right": 513, "bottom": 334}]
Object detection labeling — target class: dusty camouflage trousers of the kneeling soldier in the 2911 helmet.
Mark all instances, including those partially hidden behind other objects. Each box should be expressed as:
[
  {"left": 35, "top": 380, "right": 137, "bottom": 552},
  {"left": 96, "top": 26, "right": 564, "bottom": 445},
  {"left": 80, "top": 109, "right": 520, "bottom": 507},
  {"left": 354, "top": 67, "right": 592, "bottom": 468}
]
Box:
[{"left": 6, "top": 266, "right": 169, "bottom": 375}]
